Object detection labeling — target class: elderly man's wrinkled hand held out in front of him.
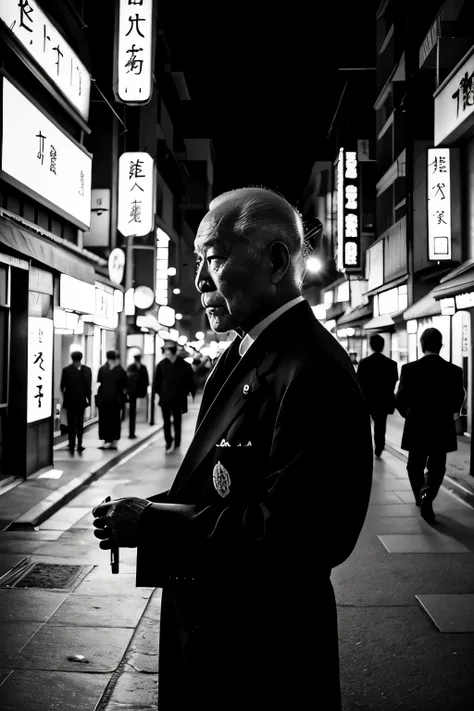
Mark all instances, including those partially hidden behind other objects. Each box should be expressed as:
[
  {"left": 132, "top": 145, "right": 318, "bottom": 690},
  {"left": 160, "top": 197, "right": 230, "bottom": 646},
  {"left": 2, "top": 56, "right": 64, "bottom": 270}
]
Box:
[{"left": 92, "top": 496, "right": 150, "bottom": 550}]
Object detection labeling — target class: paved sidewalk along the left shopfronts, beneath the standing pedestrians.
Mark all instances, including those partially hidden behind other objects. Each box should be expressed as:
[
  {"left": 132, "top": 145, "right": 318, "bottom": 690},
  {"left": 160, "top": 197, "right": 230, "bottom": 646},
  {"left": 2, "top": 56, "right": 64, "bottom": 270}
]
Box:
[{"left": 0, "top": 417, "right": 162, "bottom": 536}]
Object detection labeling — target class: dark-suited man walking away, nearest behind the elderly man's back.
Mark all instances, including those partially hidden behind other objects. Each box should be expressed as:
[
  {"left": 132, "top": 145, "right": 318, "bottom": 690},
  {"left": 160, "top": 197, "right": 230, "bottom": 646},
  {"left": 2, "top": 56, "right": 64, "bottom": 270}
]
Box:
[{"left": 357, "top": 333, "right": 398, "bottom": 457}]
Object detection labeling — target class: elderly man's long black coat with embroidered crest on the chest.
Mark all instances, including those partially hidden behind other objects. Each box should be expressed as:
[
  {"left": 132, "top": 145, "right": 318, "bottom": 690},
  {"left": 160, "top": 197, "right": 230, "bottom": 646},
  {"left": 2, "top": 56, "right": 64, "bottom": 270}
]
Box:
[{"left": 137, "top": 302, "right": 373, "bottom": 711}]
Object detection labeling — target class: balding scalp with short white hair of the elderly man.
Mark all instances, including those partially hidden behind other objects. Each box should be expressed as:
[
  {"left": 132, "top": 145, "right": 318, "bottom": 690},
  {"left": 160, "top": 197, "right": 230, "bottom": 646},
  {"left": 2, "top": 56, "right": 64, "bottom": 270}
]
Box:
[{"left": 199, "top": 188, "right": 304, "bottom": 283}]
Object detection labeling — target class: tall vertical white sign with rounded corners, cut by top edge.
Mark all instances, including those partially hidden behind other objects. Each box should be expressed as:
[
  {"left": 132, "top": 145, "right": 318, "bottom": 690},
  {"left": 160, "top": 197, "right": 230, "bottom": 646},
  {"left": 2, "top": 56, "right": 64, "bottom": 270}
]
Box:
[{"left": 116, "top": 0, "right": 154, "bottom": 104}]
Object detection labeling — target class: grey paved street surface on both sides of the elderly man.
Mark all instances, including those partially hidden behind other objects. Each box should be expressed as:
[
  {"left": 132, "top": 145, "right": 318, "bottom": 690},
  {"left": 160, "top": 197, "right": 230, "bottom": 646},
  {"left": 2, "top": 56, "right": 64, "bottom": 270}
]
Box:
[{"left": 0, "top": 398, "right": 474, "bottom": 711}]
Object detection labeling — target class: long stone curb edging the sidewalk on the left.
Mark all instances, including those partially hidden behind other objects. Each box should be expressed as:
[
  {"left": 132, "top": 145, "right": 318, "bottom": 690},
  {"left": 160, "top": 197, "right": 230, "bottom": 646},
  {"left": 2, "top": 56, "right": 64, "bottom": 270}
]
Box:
[{"left": 3, "top": 425, "right": 163, "bottom": 531}]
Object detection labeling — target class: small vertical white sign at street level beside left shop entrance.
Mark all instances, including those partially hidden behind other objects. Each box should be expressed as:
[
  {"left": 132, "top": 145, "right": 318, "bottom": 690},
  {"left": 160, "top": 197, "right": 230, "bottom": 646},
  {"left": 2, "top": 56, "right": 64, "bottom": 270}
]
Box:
[{"left": 26, "top": 316, "right": 53, "bottom": 423}]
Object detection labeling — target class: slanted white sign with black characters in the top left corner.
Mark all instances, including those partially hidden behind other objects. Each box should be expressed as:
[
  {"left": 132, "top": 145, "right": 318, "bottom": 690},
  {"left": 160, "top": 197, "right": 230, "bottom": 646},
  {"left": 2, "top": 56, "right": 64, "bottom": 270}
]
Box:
[{"left": 0, "top": 0, "right": 91, "bottom": 121}]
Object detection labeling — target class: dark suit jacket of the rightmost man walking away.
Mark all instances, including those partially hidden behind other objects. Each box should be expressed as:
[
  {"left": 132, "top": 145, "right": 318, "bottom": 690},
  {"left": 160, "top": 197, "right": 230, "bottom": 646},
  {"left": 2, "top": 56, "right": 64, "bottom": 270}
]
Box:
[{"left": 396, "top": 355, "right": 464, "bottom": 453}]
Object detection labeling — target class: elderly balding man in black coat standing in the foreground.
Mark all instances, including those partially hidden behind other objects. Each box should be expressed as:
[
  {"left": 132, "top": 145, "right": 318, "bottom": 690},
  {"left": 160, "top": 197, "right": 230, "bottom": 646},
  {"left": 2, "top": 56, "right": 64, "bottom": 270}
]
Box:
[{"left": 94, "top": 188, "right": 372, "bottom": 711}]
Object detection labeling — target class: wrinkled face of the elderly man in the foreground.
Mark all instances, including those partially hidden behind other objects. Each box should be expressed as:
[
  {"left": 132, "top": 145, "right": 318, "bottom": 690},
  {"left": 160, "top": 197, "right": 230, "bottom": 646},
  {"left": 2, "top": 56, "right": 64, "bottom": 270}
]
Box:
[{"left": 194, "top": 213, "right": 274, "bottom": 333}]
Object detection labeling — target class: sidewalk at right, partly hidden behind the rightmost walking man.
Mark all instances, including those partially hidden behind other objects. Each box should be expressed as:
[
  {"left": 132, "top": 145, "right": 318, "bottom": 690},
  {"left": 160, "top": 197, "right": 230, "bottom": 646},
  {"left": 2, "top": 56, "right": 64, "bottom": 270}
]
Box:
[{"left": 386, "top": 412, "right": 474, "bottom": 506}]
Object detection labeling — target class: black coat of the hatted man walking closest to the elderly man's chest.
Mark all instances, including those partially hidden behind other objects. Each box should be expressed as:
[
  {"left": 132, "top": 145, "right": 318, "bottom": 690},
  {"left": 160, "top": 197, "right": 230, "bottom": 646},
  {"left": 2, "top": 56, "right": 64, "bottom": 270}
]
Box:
[{"left": 153, "top": 356, "right": 196, "bottom": 412}]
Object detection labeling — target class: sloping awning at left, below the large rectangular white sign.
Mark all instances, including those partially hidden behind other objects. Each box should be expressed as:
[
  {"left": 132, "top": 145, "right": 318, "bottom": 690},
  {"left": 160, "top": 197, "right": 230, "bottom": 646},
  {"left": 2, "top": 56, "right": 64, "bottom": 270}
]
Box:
[{"left": 0, "top": 217, "right": 95, "bottom": 284}]
